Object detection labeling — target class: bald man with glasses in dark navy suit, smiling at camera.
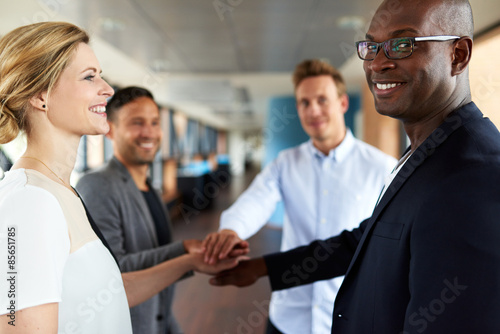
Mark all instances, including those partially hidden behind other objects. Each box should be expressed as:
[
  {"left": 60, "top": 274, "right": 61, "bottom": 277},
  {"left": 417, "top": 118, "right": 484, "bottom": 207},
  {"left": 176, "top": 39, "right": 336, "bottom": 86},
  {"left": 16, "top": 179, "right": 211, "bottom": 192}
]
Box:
[{"left": 211, "top": 0, "right": 500, "bottom": 334}]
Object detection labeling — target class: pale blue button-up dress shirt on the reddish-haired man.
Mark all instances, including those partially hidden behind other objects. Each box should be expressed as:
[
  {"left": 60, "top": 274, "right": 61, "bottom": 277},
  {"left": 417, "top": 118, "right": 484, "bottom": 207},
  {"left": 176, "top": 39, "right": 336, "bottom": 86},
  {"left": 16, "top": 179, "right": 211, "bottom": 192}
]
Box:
[{"left": 220, "top": 130, "right": 396, "bottom": 334}]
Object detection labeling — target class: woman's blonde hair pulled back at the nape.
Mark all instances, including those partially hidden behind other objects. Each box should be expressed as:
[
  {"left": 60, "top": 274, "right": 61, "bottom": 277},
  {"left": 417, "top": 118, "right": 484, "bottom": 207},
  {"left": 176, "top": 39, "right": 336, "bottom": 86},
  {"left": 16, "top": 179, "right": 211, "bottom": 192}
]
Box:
[{"left": 0, "top": 22, "right": 89, "bottom": 144}]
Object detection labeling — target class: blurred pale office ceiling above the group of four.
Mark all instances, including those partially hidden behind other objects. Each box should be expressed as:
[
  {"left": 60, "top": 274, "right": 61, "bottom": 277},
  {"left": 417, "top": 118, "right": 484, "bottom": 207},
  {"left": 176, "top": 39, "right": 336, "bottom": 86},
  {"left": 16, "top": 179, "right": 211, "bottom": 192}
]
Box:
[{"left": 0, "top": 0, "right": 500, "bottom": 130}]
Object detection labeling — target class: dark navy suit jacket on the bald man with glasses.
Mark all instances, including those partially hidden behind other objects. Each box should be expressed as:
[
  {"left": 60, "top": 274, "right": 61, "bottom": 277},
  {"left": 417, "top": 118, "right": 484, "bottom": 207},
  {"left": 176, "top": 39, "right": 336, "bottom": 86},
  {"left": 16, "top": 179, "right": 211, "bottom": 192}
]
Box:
[{"left": 264, "top": 103, "right": 500, "bottom": 334}]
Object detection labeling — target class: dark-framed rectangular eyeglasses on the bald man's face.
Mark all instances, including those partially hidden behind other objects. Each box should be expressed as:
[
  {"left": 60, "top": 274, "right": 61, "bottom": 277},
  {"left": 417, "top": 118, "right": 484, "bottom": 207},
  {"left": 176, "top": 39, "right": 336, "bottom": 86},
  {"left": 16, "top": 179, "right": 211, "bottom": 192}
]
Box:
[{"left": 356, "top": 36, "right": 460, "bottom": 60}]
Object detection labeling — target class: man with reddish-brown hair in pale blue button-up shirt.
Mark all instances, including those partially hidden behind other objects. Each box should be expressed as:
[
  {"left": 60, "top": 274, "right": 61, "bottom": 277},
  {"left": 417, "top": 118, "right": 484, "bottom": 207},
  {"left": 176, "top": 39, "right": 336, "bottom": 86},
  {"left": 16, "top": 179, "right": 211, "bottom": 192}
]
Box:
[{"left": 204, "top": 60, "right": 396, "bottom": 334}]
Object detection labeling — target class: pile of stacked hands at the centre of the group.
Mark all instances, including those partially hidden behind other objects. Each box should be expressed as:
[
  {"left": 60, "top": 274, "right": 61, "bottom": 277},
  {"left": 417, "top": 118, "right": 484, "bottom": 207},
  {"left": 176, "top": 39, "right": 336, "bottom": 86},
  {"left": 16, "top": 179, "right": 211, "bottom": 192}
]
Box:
[{"left": 184, "top": 230, "right": 267, "bottom": 286}]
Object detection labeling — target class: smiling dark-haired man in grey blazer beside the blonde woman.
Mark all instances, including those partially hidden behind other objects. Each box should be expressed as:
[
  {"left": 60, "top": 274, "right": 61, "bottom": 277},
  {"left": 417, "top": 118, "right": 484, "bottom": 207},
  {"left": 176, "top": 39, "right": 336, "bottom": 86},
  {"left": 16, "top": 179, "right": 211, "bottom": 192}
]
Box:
[{"left": 77, "top": 87, "right": 200, "bottom": 334}]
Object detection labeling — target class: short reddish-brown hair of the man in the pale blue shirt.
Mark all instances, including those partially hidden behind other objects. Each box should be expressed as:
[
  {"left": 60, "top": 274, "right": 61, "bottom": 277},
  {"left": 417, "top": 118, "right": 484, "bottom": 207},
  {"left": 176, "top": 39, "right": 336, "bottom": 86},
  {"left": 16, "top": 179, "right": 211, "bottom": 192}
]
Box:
[{"left": 293, "top": 59, "right": 347, "bottom": 96}]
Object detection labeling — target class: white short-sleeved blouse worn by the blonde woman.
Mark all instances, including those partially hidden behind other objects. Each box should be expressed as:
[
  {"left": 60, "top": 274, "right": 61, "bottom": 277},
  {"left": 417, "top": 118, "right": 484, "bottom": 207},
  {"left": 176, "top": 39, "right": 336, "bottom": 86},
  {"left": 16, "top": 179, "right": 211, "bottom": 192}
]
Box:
[{"left": 0, "top": 169, "right": 132, "bottom": 334}]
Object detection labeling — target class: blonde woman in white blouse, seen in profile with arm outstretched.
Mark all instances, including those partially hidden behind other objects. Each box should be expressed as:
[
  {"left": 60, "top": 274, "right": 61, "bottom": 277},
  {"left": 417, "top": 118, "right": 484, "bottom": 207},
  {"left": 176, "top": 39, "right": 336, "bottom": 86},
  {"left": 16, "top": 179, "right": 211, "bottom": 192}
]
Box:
[{"left": 0, "top": 22, "right": 242, "bottom": 334}]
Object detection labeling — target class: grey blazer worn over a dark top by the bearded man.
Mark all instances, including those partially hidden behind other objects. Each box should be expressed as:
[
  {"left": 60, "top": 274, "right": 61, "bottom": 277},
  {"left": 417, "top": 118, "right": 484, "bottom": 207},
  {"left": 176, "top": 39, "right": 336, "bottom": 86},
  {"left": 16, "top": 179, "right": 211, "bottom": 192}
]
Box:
[{"left": 76, "top": 157, "right": 185, "bottom": 334}]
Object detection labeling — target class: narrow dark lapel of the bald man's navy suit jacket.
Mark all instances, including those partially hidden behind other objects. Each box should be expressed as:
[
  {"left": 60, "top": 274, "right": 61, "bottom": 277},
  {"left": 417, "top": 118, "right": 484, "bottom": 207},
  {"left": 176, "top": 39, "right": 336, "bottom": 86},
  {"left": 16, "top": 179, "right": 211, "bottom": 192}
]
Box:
[{"left": 346, "top": 102, "right": 483, "bottom": 277}]
